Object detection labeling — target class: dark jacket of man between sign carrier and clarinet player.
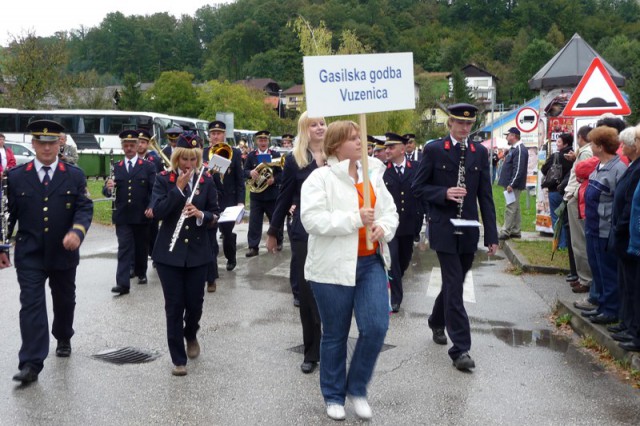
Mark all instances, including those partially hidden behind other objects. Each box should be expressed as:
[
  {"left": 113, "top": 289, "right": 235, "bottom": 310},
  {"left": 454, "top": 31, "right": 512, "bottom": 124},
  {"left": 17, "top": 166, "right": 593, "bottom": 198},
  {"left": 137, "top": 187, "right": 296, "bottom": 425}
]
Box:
[{"left": 383, "top": 160, "right": 418, "bottom": 236}]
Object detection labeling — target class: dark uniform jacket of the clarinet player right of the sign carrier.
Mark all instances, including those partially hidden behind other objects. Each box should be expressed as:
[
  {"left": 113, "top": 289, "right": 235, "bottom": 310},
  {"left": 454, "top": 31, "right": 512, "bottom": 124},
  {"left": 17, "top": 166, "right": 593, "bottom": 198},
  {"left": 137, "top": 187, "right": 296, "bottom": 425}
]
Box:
[{"left": 412, "top": 136, "right": 498, "bottom": 253}]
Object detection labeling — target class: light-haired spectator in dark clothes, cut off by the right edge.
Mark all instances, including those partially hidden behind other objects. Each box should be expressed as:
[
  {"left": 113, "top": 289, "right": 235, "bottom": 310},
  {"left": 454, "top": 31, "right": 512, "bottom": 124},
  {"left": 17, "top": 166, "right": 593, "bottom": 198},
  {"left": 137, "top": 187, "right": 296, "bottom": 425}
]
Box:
[{"left": 609, "top": 127, "right": 640, "bottom": 350}]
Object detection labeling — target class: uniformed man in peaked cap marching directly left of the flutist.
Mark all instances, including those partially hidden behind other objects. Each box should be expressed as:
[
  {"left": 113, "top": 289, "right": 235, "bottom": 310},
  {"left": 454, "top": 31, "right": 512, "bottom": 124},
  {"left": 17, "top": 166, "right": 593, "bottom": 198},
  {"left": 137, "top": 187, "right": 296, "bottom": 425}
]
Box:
[{"left": 102, "top": 130, "right": 156, "bottom": 295}]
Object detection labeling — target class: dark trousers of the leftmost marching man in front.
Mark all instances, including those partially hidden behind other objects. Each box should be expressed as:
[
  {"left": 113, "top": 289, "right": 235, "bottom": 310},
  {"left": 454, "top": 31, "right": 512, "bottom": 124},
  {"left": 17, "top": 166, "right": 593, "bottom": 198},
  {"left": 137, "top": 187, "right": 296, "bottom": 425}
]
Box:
[{"left": 17, "top": 267, "right": 76, "bottom": 372}]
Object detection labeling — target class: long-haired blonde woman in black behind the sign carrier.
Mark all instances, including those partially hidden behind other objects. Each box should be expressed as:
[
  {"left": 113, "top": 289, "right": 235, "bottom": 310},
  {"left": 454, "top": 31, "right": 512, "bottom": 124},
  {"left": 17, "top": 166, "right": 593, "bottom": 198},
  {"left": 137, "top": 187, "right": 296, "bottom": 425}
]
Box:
[{"left": 267, "top": 112, "right": 327, "bottom": 374}]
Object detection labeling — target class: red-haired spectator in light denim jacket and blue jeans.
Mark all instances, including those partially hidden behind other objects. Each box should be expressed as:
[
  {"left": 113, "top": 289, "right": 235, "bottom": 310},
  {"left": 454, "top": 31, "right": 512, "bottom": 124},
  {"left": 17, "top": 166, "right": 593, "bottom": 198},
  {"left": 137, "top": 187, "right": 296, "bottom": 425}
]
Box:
[{"left": 582, "top": 126, "right": 627, "bottom": 324}]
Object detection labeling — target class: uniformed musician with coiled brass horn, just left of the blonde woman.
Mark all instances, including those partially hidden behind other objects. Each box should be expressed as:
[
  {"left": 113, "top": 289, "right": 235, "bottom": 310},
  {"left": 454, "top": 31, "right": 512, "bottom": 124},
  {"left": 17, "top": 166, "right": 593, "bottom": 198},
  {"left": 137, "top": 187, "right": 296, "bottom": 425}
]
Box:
[{"left": 244, "top": 130, "right": 284, "bottom": 257}]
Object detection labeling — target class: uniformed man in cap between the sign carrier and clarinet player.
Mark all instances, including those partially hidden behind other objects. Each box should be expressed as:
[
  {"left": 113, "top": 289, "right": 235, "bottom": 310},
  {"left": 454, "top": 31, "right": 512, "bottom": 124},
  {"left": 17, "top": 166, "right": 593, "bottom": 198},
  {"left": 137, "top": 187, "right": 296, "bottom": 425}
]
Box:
[{"left": 383, "top": 133, "right": 418, "bottom": 312}]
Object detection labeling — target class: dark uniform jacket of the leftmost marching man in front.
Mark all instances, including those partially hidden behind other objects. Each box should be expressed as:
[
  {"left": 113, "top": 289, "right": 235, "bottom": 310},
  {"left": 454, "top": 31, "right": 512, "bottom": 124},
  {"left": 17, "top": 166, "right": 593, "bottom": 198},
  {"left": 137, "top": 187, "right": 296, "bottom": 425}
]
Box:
[{"left": 8, "top": 161, "right": 93, "bottom": 270}]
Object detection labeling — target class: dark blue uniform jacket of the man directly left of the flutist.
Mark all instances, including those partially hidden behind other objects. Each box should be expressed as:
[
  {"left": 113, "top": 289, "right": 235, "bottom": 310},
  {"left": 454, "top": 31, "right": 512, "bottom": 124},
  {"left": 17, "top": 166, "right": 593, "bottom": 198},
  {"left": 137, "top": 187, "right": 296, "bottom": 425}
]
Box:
[{"left": 102, "top": 157, "right": 156, "bottom": 225}]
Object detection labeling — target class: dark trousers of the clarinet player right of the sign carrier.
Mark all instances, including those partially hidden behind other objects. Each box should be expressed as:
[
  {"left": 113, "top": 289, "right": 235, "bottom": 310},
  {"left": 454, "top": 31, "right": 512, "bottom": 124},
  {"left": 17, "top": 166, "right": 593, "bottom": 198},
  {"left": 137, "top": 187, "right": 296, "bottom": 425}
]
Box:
[{"left": 429, "top": 252, "right": 474, "bottom": 360}]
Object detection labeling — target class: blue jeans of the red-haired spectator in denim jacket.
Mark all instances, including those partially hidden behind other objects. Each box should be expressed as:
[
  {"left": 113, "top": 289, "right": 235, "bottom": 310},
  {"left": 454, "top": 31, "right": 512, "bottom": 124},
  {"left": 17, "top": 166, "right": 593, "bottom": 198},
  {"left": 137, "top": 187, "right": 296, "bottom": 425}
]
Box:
[{"left": 586, "top": 234, "right": 620, "bottom": 318}]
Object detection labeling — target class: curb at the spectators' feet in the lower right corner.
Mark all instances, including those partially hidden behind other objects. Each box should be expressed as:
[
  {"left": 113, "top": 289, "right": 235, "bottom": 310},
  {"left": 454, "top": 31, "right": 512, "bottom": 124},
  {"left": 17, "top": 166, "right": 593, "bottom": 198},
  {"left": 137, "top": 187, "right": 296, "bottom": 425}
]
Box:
[{"left": 558, "top": 300, "right": 640, "bottom": 370}]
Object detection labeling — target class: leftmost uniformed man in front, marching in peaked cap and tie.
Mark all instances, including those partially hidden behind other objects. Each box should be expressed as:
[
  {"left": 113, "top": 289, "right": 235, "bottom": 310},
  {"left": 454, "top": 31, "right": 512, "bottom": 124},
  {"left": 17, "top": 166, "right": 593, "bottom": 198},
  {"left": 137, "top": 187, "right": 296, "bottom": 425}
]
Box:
[{"left": 0, "top": 120, "right": 93, "bottom": 384}]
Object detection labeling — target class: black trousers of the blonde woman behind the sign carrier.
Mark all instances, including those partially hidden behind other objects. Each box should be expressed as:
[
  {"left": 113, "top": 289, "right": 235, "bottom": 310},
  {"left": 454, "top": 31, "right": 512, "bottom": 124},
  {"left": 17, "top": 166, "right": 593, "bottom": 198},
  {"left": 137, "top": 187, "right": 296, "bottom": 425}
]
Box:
[{"left": 291, "top": 241, "right": 322, "bottom": 362}]
